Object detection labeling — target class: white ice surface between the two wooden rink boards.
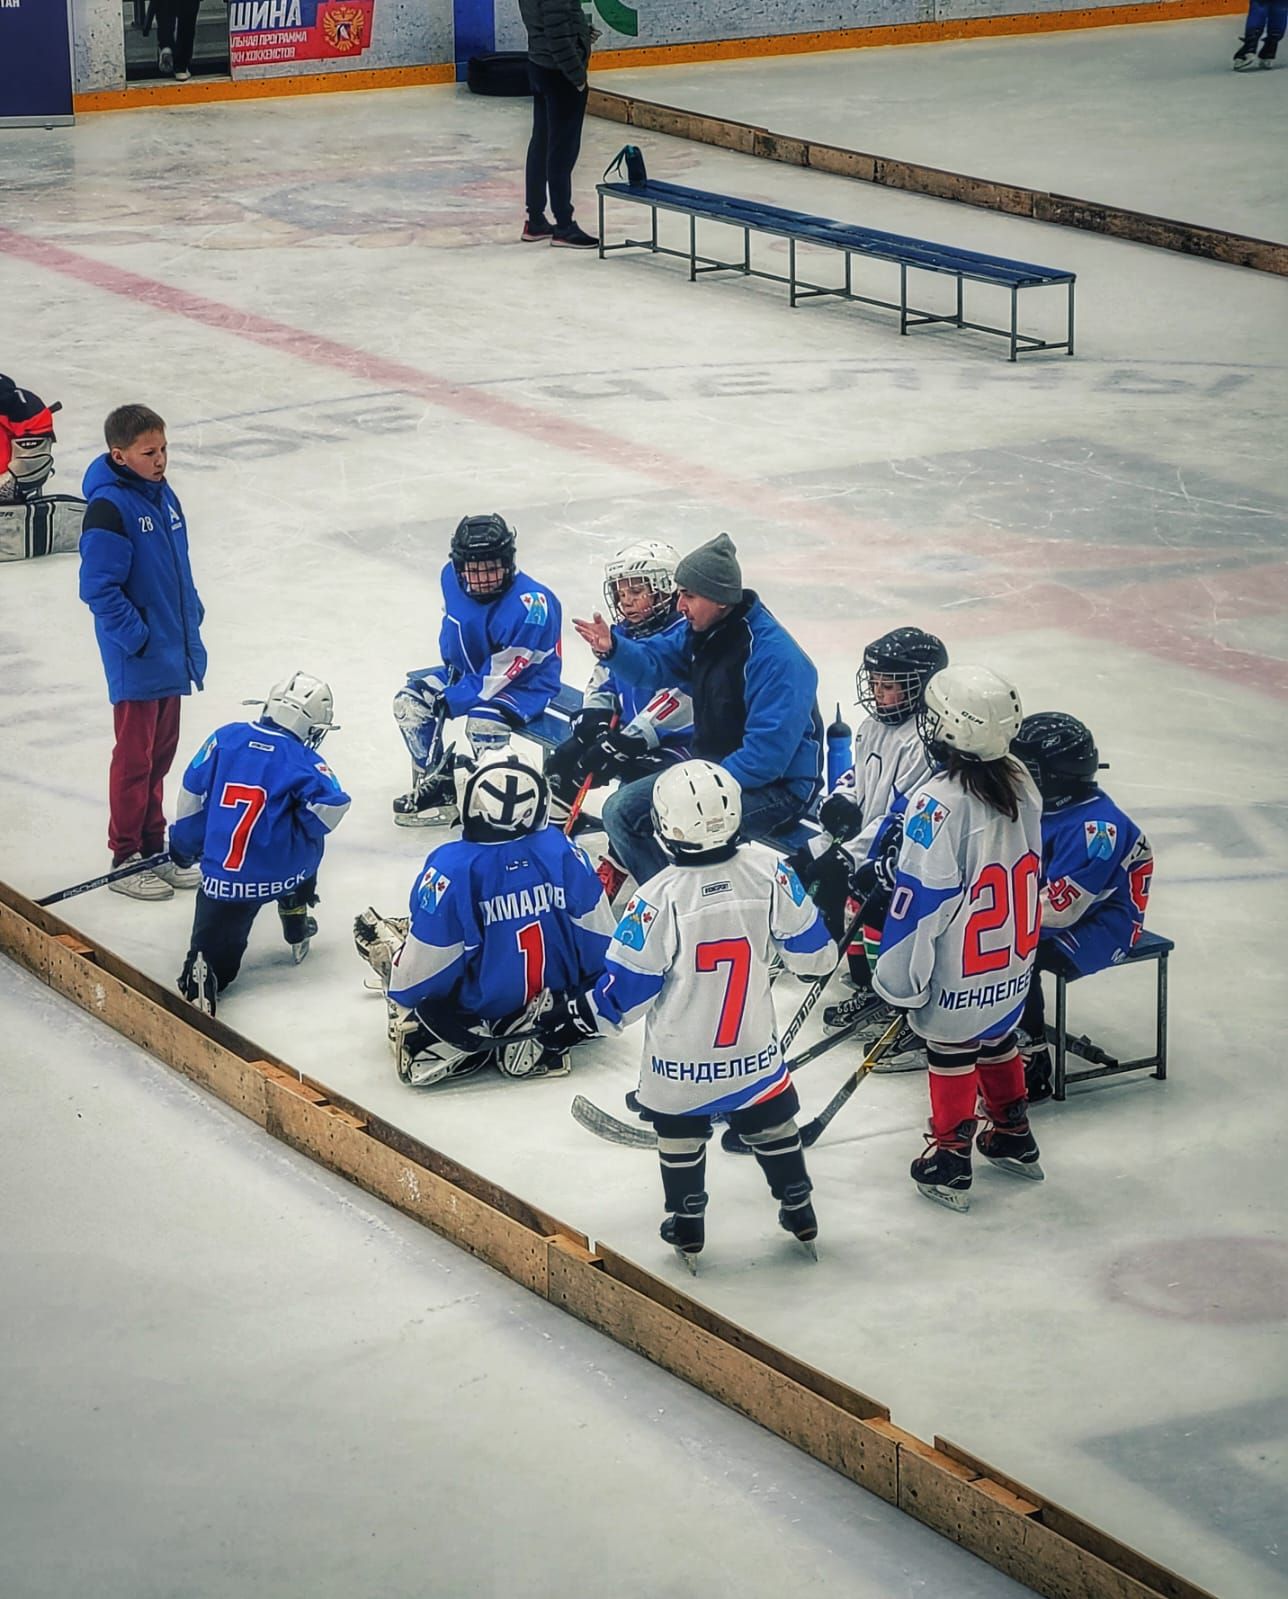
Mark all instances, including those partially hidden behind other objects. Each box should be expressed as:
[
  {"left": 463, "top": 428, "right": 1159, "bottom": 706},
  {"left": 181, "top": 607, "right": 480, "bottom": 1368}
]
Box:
[{"left": 0, "top": 24, "right": 1288, "bottom": 1599}]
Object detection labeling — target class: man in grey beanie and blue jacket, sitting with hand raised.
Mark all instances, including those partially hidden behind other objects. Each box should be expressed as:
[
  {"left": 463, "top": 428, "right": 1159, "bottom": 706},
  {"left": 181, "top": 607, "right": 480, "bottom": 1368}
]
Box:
[{"left": 574, "top": 532, "right": 823, "bottom": 883}]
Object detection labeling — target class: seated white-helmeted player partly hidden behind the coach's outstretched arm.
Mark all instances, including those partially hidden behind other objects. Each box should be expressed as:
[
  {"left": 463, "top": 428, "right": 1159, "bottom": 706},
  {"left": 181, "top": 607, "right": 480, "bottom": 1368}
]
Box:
[{"left": 545, "top": 539, "right": 694, "bottom": 820}]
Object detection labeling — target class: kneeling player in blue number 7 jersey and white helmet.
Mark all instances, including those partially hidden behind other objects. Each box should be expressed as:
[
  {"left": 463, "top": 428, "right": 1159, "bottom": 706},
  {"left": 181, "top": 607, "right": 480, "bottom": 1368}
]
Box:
[{"left": 169, "top": 672, "right": 350, "bottom": 1015}]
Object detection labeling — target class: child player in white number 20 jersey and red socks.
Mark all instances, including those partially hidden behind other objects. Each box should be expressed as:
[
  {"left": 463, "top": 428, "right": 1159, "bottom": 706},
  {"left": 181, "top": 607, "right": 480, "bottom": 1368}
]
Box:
[{"left": 873, "top": 667, "right": 1042, "bottom": 1210}]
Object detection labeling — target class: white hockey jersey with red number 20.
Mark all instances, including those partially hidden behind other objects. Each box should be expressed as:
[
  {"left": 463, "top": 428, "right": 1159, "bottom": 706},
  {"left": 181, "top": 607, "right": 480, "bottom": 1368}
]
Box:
[{"left": 873, "top": 772, "right": 1042, "bottom": 1044}]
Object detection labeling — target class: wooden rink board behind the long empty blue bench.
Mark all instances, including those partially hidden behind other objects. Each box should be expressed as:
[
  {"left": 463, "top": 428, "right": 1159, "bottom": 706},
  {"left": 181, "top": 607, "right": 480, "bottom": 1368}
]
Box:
[{"left": 586, "top": 88, "right": 1288, "bottom": 277}]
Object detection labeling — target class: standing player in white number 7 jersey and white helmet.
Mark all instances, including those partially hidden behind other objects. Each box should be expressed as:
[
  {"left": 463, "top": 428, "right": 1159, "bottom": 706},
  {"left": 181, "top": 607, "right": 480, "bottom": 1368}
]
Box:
[{"left": 536, "top": 761, "right": 836, "bottom": 1268}]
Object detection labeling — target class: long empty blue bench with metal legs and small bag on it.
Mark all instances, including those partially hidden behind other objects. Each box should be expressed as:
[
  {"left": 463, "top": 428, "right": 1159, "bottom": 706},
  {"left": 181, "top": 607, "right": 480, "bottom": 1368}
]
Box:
[{"left": 598, "top": 177, "right": 1075, "bottom": 361}]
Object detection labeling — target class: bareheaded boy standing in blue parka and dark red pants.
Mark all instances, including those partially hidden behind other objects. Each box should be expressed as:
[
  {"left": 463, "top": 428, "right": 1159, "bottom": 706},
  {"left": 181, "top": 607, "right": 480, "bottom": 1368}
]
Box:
[{"left": 80, "top": 405, "right": 206, "bottom": 900}]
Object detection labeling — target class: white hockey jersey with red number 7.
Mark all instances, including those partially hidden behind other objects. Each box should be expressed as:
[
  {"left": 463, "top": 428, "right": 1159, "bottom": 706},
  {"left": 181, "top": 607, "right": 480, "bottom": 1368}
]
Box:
[{"left": 593, "top": 844, "right": 837, "bottom": 1116}]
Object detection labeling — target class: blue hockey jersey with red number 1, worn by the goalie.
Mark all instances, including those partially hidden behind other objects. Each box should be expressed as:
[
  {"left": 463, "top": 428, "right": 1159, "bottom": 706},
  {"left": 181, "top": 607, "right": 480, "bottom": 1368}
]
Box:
[{"left": 388, "top": 827, "right": 614, "bottom": 1022}]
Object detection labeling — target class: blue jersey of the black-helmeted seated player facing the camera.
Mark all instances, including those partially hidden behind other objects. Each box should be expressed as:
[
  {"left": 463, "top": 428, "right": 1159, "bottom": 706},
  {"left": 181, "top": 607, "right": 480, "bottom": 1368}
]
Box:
[{"left": 438, "top": 561, "right": 564, "bottom": 723}]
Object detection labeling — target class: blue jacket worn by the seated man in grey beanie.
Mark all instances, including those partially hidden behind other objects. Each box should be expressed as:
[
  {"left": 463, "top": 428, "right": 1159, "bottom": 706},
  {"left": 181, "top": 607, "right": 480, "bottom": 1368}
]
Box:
[{"left": 606, "top": 588, "right": 823, "bottom": 804}]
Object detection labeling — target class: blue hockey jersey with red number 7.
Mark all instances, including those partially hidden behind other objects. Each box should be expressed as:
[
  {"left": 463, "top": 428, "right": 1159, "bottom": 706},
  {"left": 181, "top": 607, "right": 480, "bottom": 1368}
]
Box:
[{"left": 169, "top": 721, "right": 350, "bottom": 900}]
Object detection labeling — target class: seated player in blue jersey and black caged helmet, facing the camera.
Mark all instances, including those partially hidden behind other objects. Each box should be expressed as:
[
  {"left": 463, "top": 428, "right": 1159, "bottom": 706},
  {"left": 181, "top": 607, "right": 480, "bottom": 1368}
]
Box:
[{"left": 393, "top": 513, "right": 563, "bottom": 827}]
